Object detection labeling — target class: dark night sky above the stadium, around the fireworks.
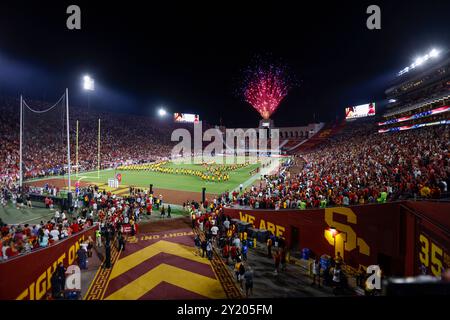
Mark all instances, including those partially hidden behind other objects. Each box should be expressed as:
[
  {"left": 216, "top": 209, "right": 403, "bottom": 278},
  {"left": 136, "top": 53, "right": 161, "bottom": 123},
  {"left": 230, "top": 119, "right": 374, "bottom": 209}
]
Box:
[{"left": 0, "top": 0, "right": 450, "bottom": 127}]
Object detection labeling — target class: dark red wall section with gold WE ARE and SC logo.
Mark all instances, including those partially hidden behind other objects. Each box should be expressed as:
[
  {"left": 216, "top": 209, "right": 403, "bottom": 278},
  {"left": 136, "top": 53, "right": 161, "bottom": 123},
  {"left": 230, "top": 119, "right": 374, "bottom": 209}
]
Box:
[{"left": 225, "top": 204, "right": 404, "bottom": 274}]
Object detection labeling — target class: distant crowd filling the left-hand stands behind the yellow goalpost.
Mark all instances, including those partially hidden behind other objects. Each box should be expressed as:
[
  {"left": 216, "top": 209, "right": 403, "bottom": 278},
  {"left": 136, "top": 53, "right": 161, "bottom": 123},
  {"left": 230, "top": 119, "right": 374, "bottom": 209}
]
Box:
[{"left": 0, "top": 97, "right": 188, "bottom": 181}]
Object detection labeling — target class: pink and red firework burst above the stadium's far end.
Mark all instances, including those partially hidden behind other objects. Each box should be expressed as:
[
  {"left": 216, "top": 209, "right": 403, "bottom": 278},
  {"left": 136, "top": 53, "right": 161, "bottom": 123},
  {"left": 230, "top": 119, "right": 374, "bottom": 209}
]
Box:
[{"left": 242, "top": 58, "right": 292, "bottom": 119}]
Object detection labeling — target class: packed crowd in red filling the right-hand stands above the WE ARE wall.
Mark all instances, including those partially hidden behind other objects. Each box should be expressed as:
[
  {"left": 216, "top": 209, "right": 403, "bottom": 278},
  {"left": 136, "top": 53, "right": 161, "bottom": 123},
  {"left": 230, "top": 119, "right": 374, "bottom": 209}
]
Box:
[{"left": 222, "top": 120, "right": 450, "bottom": 209}]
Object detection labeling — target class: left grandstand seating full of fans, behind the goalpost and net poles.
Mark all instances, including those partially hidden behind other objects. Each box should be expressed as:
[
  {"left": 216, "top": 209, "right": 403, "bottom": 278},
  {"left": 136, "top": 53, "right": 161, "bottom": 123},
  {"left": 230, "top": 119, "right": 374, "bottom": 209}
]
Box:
[{"left": 0, "top": 98, "right": 190, "bottom": 184}]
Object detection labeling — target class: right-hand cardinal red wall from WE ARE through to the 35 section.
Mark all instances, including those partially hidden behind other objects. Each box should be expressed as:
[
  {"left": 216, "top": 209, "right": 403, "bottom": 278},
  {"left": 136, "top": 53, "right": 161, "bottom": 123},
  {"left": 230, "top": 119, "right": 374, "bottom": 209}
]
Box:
[{"left": 225, "top": 202, "right": 450, "bottom": 276}]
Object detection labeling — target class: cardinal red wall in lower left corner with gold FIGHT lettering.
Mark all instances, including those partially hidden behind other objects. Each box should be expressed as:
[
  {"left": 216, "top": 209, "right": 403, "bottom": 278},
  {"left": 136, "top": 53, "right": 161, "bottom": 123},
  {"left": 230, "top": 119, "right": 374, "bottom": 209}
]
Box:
[{"left": 0, "top": 227, "right": 97, "bottom": 300}]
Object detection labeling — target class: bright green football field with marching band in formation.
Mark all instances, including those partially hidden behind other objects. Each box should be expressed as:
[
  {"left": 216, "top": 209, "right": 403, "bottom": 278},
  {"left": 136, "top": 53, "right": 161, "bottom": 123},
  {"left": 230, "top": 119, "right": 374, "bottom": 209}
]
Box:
[{"left": 72, "top": 163, "right": 260, "bottom": 193}]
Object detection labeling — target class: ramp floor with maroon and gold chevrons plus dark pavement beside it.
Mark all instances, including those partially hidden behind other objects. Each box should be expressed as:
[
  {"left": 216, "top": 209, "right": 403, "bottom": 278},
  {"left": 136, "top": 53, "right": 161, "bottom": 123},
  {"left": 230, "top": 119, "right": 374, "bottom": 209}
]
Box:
[{"left": 84, "top": 215, "right": 340, "bottom": 300}]
